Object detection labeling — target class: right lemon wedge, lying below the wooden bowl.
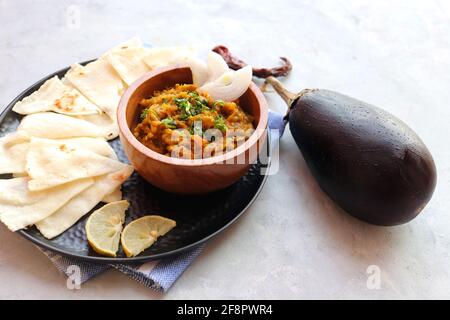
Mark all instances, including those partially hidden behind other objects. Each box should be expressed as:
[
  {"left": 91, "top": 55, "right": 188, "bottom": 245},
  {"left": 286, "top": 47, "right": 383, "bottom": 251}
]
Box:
[{"left": 121, "top": 216, "right": 176, "bottom": 257}]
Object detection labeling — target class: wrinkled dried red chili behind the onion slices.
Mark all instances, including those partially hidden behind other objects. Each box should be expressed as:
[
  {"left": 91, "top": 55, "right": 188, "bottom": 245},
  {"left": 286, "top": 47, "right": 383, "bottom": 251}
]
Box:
[{"left": 212, "top": 46, "right": 292, "bottom": 78}]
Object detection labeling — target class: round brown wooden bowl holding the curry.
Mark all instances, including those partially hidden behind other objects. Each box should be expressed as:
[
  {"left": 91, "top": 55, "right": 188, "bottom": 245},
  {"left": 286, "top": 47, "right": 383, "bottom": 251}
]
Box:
[{"left": 117, "top": 65, "right": 268, "bottom": 194}]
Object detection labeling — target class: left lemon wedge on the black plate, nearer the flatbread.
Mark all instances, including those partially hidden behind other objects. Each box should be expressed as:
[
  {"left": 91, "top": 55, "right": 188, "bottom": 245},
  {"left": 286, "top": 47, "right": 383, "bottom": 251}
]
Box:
[{"left": 86, "top": 200, "right": 130, "bottom": 257}]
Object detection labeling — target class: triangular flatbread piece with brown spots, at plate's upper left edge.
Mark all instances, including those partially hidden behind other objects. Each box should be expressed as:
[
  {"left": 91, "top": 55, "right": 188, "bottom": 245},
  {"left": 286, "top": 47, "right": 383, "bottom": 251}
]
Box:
[{"left": 13, "top": 76, "right": 101, "bottom": 115}]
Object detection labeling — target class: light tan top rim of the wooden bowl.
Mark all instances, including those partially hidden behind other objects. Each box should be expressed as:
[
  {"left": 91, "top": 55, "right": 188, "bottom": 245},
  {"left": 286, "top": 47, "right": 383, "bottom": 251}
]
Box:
[{"left": 117, "top": 64, "right": 268, "bottom": 166}]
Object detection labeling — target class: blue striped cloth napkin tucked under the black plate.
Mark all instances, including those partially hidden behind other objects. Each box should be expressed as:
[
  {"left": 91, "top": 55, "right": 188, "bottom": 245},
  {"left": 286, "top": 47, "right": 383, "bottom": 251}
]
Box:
[{"left": 40, "top": 111, "right": 286, "bottom": 293}]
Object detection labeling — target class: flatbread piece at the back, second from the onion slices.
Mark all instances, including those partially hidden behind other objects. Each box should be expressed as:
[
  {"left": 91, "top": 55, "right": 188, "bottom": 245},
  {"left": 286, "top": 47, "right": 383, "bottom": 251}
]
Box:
[{"left": 105, "top": 47, "right": 150, "bottom": 85}]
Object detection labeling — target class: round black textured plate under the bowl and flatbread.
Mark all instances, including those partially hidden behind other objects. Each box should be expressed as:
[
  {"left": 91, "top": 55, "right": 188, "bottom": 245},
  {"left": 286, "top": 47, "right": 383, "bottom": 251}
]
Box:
[{"left": 0, "top": 62, "right": 270, "bottom": 263}]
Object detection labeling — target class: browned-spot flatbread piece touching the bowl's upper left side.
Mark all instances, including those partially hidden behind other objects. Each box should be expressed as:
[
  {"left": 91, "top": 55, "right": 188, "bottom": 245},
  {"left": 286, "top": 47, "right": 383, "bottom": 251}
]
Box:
[{"left": 65, "top": 58, "right": 125, "bottom": 117}]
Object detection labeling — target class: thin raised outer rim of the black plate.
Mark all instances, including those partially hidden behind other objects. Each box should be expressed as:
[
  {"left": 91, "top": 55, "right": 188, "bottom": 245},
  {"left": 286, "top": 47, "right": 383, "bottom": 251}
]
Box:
[{"left": 0, "top": 59, "right": 271, "bottom": 264}]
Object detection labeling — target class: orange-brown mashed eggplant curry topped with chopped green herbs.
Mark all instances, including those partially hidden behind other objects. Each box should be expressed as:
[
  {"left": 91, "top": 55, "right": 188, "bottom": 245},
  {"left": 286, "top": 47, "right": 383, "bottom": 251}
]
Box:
[{"left": 133, "top": 84, "right": 255, "bottom": 159}]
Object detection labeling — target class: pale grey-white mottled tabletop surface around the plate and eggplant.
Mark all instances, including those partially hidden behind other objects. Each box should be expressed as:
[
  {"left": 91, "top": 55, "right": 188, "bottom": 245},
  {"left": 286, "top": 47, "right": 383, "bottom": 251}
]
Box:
[{"left": 0, "top": 0, "right": 450, "bottom": 299}]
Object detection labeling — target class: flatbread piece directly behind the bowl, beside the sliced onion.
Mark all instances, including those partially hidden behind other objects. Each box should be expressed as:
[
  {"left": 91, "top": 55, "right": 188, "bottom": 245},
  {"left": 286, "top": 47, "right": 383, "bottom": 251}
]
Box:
[{"left": 143, "top": 47, "right": 197, "bottom": 69}]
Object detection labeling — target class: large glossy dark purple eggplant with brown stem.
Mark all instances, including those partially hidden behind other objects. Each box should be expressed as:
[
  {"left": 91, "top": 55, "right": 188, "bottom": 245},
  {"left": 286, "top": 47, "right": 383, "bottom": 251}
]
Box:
[{"left": 266, "top": 77, "right": 436, "bottom": 226}]
